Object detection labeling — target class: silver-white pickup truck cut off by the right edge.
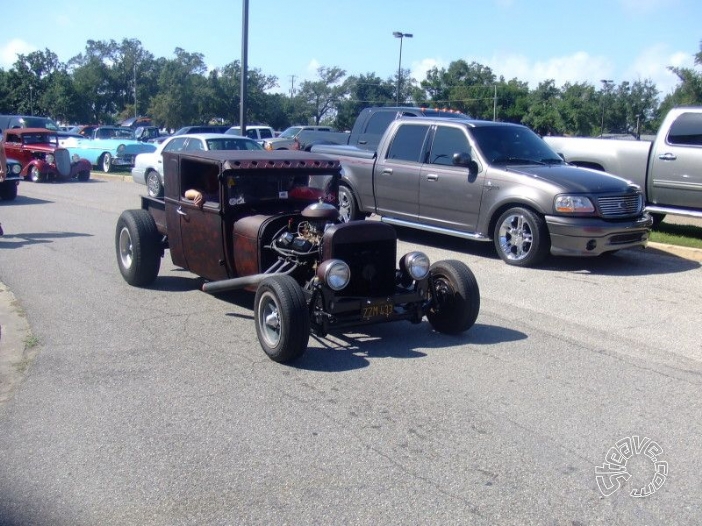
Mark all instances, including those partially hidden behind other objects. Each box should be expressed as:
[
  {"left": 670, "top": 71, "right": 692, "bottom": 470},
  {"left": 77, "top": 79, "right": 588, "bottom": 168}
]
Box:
[{"left": 544, "top": 106, "right": 702, "bottom": 222}]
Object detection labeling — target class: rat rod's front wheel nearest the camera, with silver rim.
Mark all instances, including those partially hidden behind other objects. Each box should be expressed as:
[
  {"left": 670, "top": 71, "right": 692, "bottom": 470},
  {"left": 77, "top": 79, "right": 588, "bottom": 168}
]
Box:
[{"left": 254, "top": 275, "right": 310, "bottom": 363}]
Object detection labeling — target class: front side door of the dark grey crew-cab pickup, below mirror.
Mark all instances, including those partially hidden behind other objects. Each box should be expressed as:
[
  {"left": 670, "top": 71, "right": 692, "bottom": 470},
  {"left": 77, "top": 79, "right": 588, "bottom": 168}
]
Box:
[{"left": 419, "top": 125, "right": 483, "bottom": 232}]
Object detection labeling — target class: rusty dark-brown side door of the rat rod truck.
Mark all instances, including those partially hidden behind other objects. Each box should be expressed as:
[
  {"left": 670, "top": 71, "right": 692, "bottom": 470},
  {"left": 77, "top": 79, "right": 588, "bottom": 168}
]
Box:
[{"left": 177, "top": 169, "right": 229, "bottom": 281}]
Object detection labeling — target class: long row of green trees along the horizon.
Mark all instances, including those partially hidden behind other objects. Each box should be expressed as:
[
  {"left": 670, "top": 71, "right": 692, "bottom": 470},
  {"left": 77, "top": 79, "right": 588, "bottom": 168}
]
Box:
[{"left": 0, "top": 39, "right": 702, "bottom": 136}]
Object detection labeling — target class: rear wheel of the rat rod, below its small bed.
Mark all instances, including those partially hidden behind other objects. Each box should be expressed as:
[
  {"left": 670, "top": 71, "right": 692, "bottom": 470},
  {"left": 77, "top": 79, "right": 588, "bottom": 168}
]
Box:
[{"left": 115, "top": 210, "right": 161, "bottom": 287}]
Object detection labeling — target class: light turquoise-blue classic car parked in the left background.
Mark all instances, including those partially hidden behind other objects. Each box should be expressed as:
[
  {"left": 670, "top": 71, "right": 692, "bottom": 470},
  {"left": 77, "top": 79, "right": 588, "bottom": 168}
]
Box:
[{"left": 59, "top": 126, "right": 156, "bottom": 173}]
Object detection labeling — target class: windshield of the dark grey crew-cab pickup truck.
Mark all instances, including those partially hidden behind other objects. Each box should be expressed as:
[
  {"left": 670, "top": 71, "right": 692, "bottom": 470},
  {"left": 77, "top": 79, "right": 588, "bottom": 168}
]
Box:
[{"left": 472, "top": 126, "right": 565, "bottom": 164}]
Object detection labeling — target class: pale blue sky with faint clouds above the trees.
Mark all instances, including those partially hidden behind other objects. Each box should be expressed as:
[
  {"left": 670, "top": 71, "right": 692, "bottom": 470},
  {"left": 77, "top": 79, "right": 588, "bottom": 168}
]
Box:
[{"left": 0, "top": 0, "right": 702, "bottom": 95}]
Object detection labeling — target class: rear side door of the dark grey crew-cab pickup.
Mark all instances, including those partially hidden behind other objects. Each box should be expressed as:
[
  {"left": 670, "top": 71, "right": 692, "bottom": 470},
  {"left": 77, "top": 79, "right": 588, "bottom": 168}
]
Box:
[{"left": 373, "top": 123, "right": 429, "bottom": 220}]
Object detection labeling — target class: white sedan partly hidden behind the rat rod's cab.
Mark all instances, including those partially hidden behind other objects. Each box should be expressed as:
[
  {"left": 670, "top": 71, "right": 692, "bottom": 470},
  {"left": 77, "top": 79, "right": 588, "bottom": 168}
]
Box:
[{"left": 132, "top": 133, "right": 263, "bottom": 197}]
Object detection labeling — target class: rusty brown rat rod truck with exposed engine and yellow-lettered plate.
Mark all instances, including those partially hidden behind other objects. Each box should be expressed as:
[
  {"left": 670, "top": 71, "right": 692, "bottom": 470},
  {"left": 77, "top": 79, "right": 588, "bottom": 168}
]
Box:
[{"left": 115, "top": 150, "right": 480, "bottom": 362}]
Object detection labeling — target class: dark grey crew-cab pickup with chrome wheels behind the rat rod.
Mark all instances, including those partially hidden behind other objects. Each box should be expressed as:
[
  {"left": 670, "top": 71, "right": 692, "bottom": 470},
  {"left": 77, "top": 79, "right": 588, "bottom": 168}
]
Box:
[{"left": 312, "top": 117, "right": 653, "bottom": 266}]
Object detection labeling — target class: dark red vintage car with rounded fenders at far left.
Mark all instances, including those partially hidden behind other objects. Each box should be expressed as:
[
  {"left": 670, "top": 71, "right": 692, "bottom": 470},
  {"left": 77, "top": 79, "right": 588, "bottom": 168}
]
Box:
[{"left": 3, "top": 128, "right": 91, "bottom": 183}]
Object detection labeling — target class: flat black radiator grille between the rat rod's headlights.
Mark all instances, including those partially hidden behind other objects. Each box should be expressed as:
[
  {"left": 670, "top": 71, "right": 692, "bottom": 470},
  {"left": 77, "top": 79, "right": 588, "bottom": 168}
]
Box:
[{"left": 333, "top": 240, "right": 395, "bottom": 297}]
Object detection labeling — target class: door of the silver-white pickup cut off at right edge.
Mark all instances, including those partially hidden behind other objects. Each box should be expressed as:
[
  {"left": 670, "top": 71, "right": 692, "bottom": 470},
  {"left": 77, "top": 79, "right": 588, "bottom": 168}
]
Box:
[{"left": 646, "top": 112, "right": 702, "bottom": 209}]
